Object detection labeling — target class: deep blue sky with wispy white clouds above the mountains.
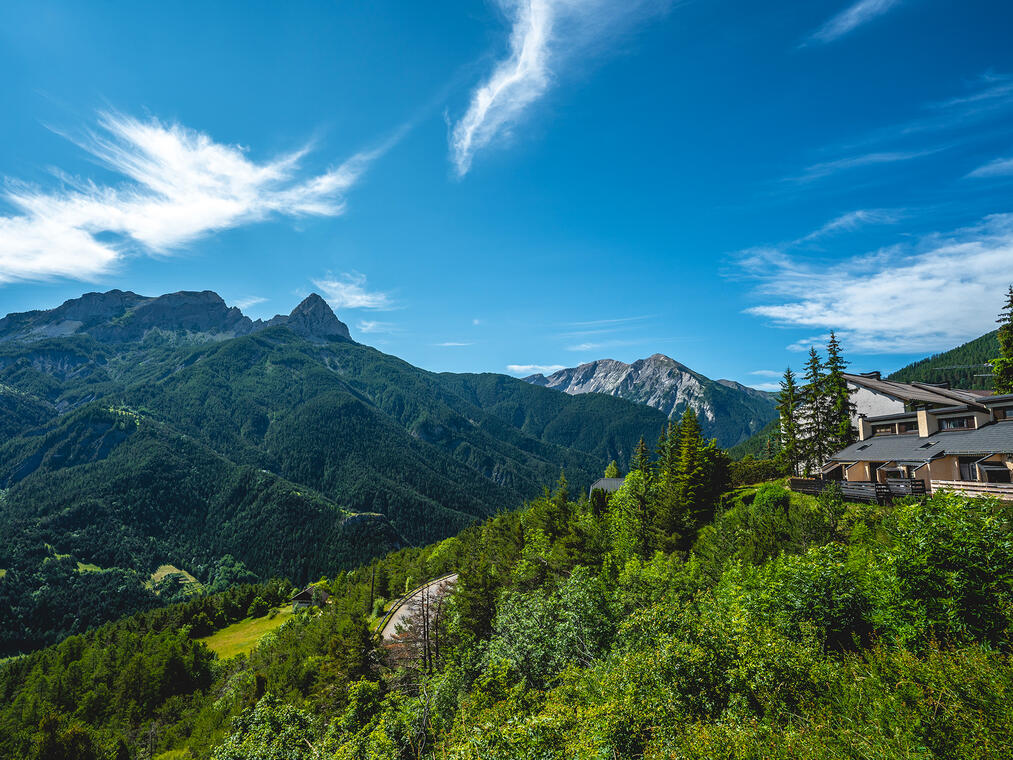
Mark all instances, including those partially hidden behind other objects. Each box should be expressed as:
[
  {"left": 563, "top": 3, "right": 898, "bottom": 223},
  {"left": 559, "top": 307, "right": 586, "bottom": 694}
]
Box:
[{"left": 0, "top": 0, "right": 1013, "bottom": 387}]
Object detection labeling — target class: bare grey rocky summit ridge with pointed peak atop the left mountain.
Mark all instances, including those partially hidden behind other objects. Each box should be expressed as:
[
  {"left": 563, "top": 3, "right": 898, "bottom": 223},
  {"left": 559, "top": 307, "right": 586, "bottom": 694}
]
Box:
[{"left": 0, "top": 290, "right": 352, "bottom": 343}]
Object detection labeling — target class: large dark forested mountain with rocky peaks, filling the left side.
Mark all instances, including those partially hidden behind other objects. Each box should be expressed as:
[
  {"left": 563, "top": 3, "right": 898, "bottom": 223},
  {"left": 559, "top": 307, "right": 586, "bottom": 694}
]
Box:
[{"left": 0, "top": 291, "right": 666, "bottom": 657}]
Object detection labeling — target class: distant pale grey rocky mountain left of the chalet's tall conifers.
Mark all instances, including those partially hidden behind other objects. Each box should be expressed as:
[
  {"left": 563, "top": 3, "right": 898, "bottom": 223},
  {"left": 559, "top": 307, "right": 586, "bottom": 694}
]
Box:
[{"left": 525, "top": 354, "right": 777, "bottom": 448}]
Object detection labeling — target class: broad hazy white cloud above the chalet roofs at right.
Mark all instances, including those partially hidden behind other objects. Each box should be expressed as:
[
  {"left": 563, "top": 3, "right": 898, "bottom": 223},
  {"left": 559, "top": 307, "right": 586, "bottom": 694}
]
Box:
[{"left": 743, "top": 214, "right": 1013, "bottom": 354}]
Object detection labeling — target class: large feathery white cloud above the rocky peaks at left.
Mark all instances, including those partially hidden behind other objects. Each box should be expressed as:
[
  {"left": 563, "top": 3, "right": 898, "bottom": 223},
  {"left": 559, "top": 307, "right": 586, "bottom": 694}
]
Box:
[{"left": 0, "top": 112, "right": 377, "bottom": 283}]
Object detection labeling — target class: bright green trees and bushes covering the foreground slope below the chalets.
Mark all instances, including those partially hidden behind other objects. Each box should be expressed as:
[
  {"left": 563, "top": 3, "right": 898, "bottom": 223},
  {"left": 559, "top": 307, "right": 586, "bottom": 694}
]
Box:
[{"left": 0, "top": 426, "right": 1013, "bottom": 760}]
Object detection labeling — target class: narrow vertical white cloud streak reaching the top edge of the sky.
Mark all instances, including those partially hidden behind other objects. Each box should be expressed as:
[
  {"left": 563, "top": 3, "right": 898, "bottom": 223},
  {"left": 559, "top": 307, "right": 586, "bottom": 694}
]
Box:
[{"left": 450, "top": 0, "right": 669, "bottom": 176}]
